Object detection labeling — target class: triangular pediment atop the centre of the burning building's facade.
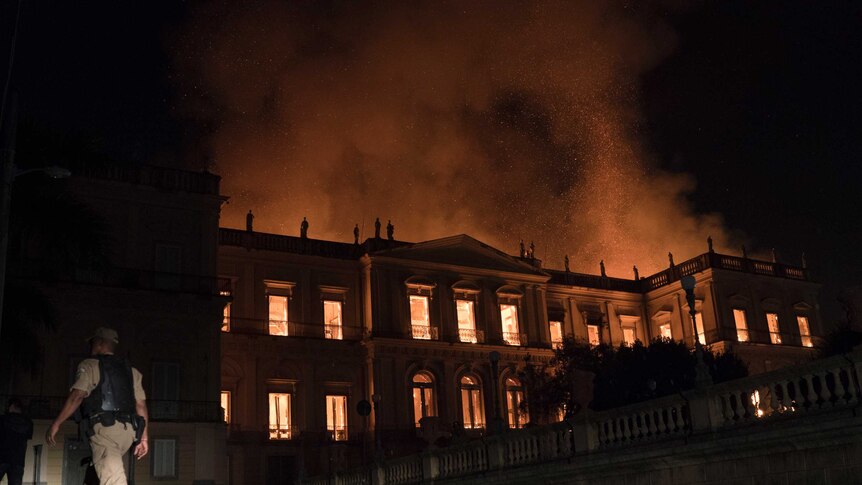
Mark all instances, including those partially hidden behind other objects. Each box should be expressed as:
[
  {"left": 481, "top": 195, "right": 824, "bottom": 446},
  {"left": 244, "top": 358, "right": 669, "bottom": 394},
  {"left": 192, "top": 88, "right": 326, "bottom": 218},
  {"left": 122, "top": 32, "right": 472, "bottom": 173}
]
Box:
[{"left": 373, "top": 234, "right": 546, "bottom": 276}]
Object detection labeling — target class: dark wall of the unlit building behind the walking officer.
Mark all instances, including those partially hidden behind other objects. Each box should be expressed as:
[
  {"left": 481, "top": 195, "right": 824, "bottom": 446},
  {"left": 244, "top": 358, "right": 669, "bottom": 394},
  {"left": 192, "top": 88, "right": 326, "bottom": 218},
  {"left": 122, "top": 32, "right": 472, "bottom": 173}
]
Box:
[{"left": 4, "top": 165, "right": 228, "bottom": 485}]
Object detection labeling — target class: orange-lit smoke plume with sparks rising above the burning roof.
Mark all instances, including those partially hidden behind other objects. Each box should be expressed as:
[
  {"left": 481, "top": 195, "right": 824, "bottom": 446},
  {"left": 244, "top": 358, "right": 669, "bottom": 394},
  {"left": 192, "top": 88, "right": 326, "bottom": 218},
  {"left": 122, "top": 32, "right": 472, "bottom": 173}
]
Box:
[{"left": 175, "top": 1, "right": 729, "bottom": 277}]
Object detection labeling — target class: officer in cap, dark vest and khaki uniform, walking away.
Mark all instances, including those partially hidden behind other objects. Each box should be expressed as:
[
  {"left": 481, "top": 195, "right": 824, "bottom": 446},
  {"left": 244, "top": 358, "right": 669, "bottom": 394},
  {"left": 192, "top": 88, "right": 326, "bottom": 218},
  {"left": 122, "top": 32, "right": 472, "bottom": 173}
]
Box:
[{"left": 45, "top": 327, "right": 149, "bottom": 485}]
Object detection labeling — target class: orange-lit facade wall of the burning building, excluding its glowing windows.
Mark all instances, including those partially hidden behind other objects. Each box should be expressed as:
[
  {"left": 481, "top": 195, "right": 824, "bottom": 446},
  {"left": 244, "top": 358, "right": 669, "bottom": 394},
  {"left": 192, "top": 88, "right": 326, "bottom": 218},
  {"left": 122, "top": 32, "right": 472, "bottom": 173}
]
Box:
[{"left": 219, "top": 230, "right": 832, "bottom": 484}]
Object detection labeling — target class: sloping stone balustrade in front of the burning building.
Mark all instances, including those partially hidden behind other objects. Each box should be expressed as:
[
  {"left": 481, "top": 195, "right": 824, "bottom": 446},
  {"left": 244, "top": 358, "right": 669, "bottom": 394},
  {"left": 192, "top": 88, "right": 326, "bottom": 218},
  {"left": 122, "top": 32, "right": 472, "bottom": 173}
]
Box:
[{"left": 301, "top": 347, "right": 862, "bottom": 485}]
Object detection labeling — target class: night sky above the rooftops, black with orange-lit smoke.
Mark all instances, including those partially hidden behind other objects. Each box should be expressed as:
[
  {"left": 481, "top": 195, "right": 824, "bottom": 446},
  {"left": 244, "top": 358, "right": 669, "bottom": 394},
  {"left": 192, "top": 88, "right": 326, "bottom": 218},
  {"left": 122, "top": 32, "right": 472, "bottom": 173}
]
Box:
[{"left": 0, "top": 0, "right": 862, "bottom": 318}]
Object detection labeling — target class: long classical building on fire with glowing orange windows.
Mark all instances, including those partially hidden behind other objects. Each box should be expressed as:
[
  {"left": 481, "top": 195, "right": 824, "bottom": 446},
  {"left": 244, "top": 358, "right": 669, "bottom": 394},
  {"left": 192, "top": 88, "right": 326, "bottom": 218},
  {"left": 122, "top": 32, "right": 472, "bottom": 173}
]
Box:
[{"left": 218, "top": 221, "right": 823, "bottom": 483}]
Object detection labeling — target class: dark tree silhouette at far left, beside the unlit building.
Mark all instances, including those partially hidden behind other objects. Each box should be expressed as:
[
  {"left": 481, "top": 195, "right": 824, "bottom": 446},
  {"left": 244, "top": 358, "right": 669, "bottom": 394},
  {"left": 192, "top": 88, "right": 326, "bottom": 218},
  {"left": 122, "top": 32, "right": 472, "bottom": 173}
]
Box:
[{"left": 0, "top": 123, "right": 110, "bottom": 394}]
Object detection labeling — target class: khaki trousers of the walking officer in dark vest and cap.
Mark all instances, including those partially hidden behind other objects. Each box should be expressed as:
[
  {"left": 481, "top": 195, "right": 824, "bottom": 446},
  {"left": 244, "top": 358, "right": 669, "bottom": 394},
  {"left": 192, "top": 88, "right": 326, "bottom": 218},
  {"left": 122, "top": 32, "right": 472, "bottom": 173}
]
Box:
[{"left": 90, "top": 421, "right": 135, "bottom": 485}]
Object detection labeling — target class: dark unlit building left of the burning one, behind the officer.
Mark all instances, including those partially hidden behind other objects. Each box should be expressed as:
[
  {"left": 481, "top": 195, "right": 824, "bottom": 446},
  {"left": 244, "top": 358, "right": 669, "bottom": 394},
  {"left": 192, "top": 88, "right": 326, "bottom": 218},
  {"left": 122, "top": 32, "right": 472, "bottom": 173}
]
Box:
[{"left": 0, "top": 164, "right": 230, "bottom": 485}]
